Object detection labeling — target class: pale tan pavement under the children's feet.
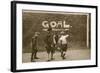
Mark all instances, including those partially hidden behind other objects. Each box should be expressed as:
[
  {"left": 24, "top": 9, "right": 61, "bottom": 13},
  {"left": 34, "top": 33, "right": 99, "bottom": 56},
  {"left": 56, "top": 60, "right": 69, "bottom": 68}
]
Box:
[{"left": 22, "top": 49, "right": 91, "bottom": 63}]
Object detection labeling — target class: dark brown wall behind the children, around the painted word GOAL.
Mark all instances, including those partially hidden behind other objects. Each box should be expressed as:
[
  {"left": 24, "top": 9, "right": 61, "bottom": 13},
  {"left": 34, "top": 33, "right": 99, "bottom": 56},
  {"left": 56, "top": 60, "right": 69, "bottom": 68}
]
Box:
[{"left": 22, "top": 10, "right": 90, "bottom": 52}]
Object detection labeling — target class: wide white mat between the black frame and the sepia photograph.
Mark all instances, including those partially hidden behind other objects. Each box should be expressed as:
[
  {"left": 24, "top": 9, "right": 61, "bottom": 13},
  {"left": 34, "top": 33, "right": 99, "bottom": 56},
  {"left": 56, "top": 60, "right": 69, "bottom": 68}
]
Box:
[{"left": 16, "top": 4, "right": 96, "bottom": 70}]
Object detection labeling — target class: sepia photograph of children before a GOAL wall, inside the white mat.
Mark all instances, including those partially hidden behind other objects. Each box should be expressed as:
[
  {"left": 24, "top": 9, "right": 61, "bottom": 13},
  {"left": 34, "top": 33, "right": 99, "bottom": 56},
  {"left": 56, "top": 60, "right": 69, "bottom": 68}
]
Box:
[{"left": 22, "top": 10, "right": 91, "bottom": 63}]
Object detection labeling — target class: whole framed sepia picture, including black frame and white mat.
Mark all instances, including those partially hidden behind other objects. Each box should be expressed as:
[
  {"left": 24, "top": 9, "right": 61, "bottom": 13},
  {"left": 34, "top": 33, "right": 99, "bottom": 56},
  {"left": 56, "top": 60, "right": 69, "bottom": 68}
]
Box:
[{"left": 11, "top": 1, "right": 97, "bottom": 72}]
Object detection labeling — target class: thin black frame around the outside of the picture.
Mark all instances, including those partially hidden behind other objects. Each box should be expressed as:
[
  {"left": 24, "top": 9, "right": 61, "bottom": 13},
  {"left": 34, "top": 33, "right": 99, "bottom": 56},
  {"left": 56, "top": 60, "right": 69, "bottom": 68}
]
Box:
[{"left": 11, "top": 1, "right": 98, "bottom": 72}]
